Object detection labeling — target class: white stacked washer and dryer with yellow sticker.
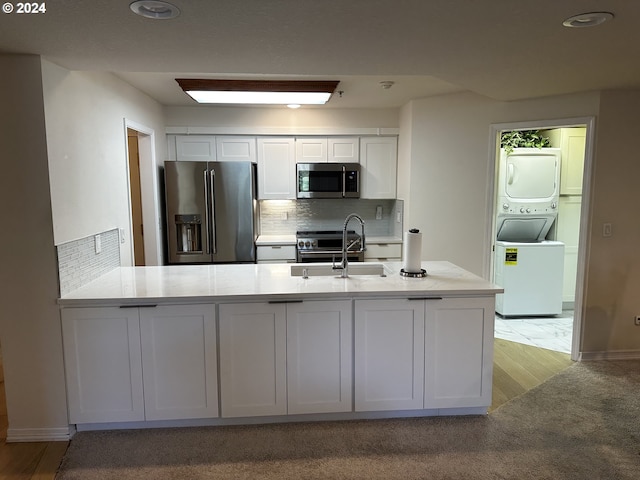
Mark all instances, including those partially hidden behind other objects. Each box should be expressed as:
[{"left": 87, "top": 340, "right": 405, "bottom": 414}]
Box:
[{"left": 494, "top": 148, "right": 564, "bottom": 317}]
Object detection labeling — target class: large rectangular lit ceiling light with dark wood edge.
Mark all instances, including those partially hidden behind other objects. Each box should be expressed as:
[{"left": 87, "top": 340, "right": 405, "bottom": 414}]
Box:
[{"left": 176, "top": 78, "right": 340, "bottom": 105}]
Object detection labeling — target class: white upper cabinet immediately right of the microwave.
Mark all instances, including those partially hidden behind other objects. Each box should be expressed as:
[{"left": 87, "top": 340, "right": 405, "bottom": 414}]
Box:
[{"left": 360, "top": 137, "right": 398, "bottom": 198}]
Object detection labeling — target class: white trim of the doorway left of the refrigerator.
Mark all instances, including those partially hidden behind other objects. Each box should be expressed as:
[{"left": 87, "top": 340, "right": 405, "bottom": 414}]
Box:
[{"left": 124, "top": 117, "right": 162, "bottom": 265}]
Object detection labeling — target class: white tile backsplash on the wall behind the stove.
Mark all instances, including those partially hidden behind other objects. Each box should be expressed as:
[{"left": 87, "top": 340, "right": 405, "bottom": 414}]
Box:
[{"left": 260, "top": 199, "right": 403, "bottom": 236}]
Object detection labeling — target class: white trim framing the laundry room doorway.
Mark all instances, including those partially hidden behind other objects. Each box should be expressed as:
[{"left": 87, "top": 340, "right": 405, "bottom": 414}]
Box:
[{"left": 485, "top": 116, "right": 596, "bottom": 361}]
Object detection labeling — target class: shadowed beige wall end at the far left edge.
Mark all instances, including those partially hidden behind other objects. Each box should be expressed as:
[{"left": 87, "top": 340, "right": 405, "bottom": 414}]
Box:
[{"left": 0, "top": 55, "right": 68, "bottom": 440}]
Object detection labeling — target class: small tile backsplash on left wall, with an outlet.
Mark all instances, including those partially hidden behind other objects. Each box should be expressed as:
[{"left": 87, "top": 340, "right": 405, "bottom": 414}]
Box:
[{"left": 56, "top": 229, "right": 120, "bottom": 296}]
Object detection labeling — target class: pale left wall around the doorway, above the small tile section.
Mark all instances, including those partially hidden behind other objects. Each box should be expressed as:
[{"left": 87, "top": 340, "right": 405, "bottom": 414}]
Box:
[{"left": 42, "top": 61, "right": 166, "bottom": 265}]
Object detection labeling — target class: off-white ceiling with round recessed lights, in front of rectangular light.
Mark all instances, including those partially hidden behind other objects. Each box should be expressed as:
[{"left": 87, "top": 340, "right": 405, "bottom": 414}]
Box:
[{"left": 0, "top": 0, "right": 640, "bottom": 108}]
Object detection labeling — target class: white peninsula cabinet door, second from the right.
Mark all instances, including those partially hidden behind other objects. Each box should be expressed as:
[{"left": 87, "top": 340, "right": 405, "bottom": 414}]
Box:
[{"left": 354, "top": 300, "right": 425, "bottom": 411}]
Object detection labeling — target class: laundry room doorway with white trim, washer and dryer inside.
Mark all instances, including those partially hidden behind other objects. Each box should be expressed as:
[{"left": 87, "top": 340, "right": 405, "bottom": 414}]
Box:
[{"left": 488, "top": 118, "right": 594, "bottom": 360}]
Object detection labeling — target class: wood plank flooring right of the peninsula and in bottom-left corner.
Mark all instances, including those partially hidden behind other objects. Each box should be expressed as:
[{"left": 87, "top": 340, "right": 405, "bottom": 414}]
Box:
[{"left": 0, "top": 338, "right": 572, "bottom": 480}]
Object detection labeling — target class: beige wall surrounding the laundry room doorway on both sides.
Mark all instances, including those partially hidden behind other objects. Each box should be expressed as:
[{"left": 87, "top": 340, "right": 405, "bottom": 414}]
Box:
[{"left": 399, "top": 91, "right": 640, "bottom": 355}]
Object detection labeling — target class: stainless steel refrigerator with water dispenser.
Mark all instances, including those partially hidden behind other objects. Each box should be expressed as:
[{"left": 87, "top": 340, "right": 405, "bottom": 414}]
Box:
[{"left": 164, "top": 161, "right": 256, "bottom": 264}]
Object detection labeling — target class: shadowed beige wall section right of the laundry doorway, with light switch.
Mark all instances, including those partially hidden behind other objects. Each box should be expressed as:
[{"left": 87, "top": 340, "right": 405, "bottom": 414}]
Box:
[{"left": 583, "top": 90, "right": 640, "bottom": 352}]
